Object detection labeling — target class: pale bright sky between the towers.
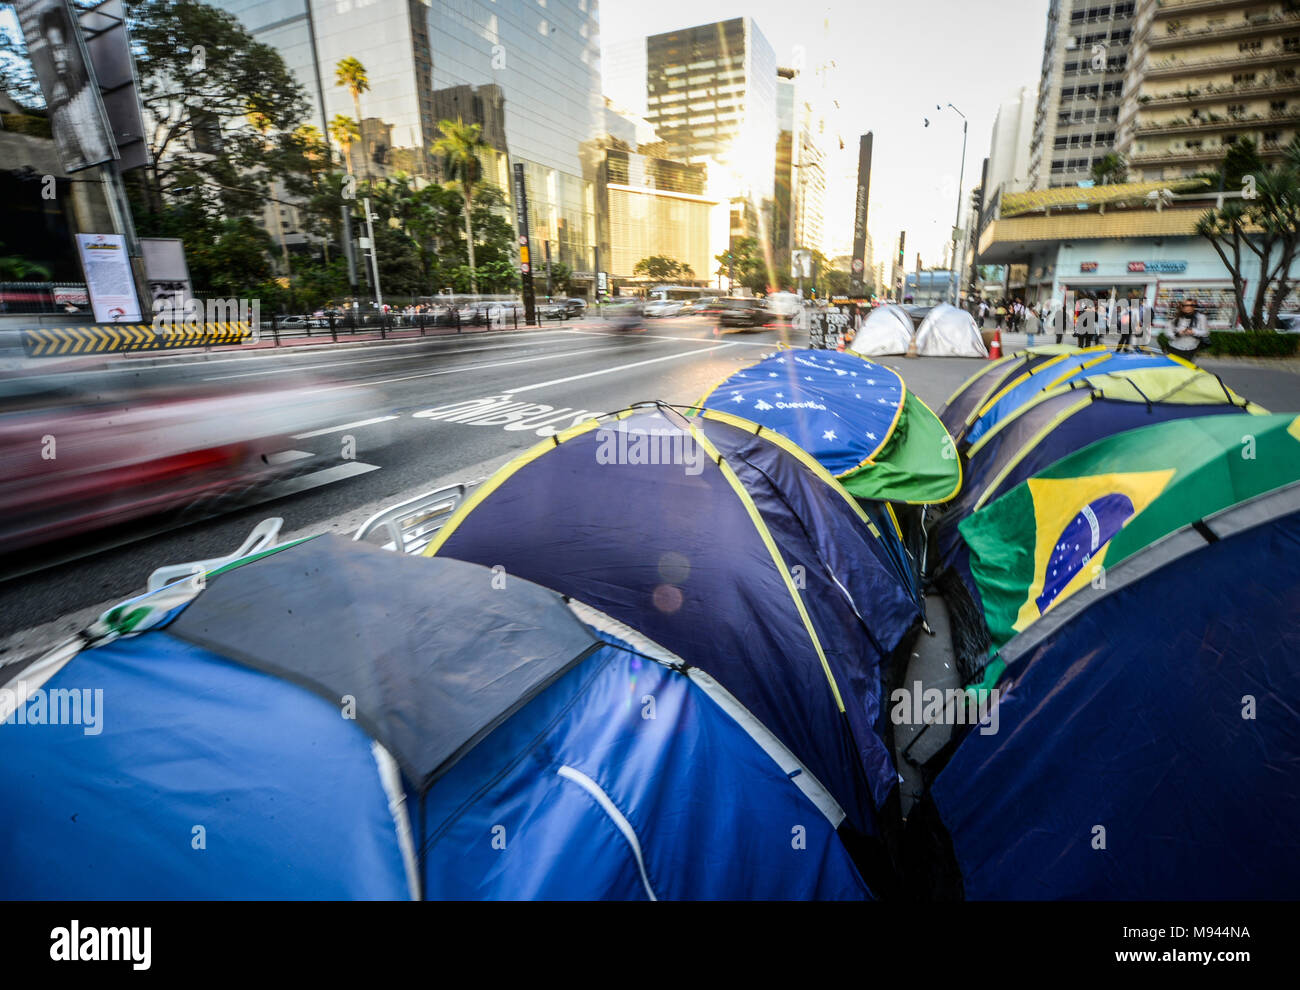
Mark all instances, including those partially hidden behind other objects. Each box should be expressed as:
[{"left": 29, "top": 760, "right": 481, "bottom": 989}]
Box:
[{"left": 601, "top": 0, "right": 1048, "bottom": 270}]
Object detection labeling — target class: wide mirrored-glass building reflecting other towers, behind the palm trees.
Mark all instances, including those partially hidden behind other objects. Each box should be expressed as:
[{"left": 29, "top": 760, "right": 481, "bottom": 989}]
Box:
[{"left": 212, "top": 0, "right": 605, "bottom": 274}]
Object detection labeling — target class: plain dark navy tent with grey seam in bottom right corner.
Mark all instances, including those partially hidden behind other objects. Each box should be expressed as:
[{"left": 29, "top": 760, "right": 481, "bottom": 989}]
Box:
[{"left": 909, "top": 485, "right": 1300, "bottom": 900}]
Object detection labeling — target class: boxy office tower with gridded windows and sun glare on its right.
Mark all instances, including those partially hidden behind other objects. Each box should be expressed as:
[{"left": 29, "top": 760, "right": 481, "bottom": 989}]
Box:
[{"left": 645, "top": 17, "right": 777, "bottom": 236}]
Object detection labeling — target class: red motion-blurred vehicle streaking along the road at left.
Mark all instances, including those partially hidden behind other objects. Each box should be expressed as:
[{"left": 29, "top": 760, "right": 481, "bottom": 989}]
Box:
[{"left": 0, "top": 374, "right": 376, "bottom": 556}]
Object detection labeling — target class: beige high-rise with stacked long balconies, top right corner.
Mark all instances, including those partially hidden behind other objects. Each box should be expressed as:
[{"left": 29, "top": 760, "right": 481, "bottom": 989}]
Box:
[{"left": 1118, "top": 0, "right": 1300, "bottom": 181}]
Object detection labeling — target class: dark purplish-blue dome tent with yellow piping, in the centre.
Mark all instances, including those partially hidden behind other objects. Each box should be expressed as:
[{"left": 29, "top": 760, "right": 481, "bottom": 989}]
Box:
[{"left": 428, "top": 405, "right": 920, "bottom": 841}]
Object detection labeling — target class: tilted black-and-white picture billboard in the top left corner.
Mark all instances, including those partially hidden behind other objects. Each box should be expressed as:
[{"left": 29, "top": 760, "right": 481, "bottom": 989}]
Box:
[{"left": 14, "top": 0, "right": 117, "bottom": 173}]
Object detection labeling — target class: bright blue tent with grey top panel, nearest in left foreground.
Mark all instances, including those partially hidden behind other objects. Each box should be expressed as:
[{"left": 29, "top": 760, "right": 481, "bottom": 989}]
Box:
[{"left": 0, "top": 537, "right": 870, "bottom": 899}]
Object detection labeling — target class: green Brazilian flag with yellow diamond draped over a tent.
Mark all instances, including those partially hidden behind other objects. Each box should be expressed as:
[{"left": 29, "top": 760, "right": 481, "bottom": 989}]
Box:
[{"left": 958, "top": 413, "right": 1300, "bottom": 646}]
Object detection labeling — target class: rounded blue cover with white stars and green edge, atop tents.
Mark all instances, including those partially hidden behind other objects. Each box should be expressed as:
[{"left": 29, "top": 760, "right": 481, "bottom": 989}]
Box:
[{"left": 697, "top": 349, "right": 962, "bottom": 504}]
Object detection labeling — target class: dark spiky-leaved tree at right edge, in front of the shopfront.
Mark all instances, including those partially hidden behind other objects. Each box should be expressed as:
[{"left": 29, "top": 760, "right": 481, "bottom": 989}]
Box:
[{"left": 1196, "top": 135, "right": 1300, "bottom": 330}]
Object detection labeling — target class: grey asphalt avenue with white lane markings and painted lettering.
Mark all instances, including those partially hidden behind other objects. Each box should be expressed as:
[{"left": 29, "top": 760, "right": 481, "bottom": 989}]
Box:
[{"left": 0, "top": 317, "right": 1300, "bottom": 659}]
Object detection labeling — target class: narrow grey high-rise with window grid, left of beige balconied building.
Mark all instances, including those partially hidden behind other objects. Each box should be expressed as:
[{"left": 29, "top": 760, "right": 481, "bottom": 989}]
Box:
[{"left": 1030, "top": 0, "right": 1136, "bottom": 188}]
